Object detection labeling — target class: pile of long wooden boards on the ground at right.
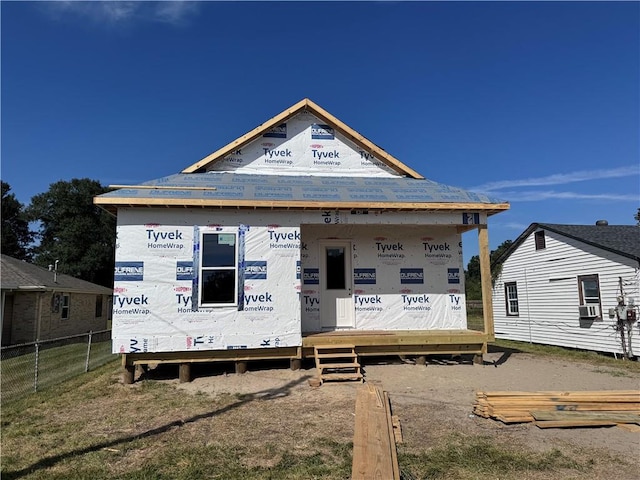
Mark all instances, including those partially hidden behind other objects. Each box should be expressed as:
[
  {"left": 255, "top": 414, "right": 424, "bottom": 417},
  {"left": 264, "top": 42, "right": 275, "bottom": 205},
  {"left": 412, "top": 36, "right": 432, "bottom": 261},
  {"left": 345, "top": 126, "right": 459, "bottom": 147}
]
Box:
[{"left": 473, "top": 390, "right": 640, "bottom": 428}]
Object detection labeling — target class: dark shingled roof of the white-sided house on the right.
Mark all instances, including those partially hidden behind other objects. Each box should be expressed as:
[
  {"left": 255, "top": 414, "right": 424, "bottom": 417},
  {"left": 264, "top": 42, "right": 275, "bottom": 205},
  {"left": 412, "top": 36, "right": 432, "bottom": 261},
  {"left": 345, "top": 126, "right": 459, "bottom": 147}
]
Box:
[{"left": 492, "top": 223, "right": 640, "bottom": 264}]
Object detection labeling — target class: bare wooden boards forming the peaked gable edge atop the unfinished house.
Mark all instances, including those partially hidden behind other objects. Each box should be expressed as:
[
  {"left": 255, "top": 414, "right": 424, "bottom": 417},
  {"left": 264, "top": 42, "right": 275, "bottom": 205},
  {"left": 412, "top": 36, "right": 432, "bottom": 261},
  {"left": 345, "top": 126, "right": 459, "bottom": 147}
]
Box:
[{"left": 182, "top": 98, "right": 424, "bottom": 178}]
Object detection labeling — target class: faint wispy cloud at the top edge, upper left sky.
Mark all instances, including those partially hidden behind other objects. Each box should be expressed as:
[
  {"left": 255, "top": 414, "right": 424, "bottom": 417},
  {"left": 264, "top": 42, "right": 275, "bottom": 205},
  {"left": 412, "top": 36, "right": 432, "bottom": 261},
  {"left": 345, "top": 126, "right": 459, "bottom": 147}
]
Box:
[{"left": 44, "top": 1, "right": 198, "bottom": 25}]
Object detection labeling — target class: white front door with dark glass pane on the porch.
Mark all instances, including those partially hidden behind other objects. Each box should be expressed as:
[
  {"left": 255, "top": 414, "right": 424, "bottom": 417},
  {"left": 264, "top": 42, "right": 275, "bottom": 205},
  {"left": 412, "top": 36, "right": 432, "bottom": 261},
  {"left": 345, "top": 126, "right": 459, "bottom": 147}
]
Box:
[{"left": 319, "top": 240, "right": 355, "bottom": 330}]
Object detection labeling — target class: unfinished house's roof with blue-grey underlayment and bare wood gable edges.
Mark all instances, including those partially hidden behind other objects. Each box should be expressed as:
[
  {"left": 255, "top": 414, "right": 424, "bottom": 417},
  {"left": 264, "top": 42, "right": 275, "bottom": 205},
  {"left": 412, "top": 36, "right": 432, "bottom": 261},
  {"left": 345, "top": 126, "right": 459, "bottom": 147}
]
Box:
[{"left": 94, "top": 99, "right": 509, "bottom": 218}]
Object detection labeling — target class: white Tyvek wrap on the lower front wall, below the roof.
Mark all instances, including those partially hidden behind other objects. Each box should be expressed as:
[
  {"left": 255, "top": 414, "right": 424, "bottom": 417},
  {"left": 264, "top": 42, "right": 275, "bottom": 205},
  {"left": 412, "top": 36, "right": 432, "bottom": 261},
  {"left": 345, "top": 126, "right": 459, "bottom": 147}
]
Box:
[{"left": 113, "top": 208, "right": 470, "bottom": 353}]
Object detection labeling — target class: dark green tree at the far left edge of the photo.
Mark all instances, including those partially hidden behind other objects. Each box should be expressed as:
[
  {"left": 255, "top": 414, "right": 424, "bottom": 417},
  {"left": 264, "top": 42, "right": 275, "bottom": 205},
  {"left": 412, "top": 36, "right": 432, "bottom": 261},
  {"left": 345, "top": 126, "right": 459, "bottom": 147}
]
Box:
[{"left": 0, "top": 180, "right": 33, "bottom": 260}]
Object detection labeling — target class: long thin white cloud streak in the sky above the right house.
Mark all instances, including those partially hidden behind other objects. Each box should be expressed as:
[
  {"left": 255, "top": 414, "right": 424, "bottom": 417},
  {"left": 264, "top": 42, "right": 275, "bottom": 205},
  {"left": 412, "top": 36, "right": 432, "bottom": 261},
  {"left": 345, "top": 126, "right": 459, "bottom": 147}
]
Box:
[{"left": 469, "top": 165, "right": 640, "bottom": 192}]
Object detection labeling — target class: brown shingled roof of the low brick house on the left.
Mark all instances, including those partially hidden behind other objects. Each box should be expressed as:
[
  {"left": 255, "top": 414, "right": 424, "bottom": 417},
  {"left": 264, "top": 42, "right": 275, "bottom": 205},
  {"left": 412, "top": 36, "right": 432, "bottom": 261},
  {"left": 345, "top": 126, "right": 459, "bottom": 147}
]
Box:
[{"left": 0, "top": 254, "right": 113, "bottom": 295}]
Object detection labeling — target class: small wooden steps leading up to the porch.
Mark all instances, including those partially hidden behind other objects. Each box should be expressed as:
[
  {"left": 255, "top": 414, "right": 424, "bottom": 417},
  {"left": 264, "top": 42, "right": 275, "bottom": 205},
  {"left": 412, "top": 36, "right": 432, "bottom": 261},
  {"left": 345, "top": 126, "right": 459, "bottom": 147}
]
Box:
[{"left": 313, "top": 345, "right": 364, "bottom": 384}]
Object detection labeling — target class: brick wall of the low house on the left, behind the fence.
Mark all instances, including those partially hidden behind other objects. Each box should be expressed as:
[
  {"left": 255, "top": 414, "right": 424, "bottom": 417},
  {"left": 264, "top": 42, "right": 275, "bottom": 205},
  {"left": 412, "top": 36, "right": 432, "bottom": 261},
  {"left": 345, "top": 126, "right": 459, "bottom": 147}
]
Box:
[{"left": 5, "top": 292, "right": 110, "bottom": 345}]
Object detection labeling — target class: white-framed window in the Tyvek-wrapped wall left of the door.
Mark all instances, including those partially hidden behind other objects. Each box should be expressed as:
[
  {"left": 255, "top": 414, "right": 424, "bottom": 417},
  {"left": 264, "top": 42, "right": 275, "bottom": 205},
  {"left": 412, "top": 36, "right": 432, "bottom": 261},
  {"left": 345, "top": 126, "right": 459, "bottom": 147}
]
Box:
[{"left": 198, "top": 233, "right": 238, "bottom": 307}]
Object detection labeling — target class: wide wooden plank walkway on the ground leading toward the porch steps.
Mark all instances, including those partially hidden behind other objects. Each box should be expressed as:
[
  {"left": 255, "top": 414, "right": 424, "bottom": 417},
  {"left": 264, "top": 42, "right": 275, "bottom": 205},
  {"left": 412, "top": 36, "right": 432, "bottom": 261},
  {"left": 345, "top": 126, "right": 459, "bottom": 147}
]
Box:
[{"left": 351, "top": 384, "right": 400, "bottom": 480}]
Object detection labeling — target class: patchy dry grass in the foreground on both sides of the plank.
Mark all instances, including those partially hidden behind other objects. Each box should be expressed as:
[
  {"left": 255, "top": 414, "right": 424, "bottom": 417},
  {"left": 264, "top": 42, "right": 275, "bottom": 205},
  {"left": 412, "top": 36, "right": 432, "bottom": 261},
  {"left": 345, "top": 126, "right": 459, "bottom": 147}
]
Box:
[{"left": 1, "top": 342, "right": 637, "bottom": 480}]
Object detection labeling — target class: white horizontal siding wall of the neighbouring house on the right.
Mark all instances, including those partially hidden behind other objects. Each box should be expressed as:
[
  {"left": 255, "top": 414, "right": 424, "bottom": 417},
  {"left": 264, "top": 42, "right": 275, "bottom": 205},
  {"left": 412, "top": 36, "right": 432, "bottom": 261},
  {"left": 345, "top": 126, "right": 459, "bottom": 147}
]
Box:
[{"left": 493, "top": 230, "right": 640, "bottom": 353}]
